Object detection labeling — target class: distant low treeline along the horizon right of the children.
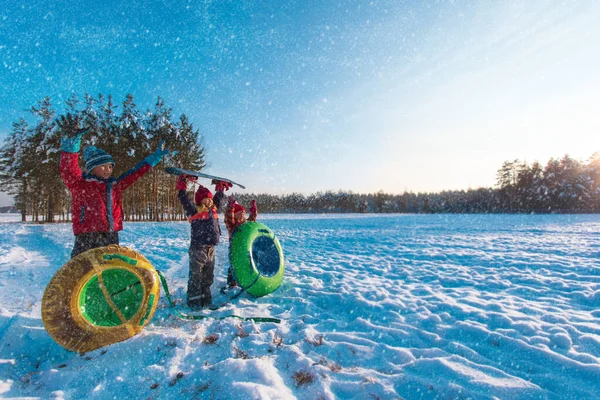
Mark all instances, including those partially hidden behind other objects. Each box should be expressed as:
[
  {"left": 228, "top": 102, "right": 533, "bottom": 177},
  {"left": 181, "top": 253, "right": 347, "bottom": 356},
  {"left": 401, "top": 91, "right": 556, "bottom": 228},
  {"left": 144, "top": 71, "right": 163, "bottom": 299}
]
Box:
[{"left": 236, "top": 153, "right": 600, "bottom": 213}]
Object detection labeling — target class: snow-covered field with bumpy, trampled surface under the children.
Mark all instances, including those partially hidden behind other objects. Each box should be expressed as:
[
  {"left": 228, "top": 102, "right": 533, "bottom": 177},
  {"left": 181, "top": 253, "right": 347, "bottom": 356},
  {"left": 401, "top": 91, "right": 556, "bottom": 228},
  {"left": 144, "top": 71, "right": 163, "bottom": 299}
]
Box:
[{"left": 0, "top": 215, "right": 600, "bottom": 400}]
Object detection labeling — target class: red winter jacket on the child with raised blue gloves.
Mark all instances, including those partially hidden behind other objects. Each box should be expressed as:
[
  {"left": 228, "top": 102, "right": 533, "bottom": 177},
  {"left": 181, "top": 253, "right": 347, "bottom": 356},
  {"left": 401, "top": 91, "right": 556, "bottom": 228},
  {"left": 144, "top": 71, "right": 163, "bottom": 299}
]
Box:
[{"left": 60, "top": 151, "right": 152, "bottom": 235}]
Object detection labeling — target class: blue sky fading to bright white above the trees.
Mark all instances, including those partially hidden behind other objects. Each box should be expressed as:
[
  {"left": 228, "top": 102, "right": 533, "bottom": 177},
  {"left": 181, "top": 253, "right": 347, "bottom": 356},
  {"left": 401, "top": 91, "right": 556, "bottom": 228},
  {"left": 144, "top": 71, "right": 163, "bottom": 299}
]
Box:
[{"left": 0, "top": 0, "right": 600, "bottom": 206}]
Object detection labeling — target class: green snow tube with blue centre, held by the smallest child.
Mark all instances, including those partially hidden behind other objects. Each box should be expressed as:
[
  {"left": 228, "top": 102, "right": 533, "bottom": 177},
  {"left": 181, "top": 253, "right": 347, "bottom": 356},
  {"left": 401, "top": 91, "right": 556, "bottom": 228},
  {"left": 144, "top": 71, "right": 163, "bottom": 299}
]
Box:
[{"left": 229, "top": 222, "right": 284, "bottom": 297}]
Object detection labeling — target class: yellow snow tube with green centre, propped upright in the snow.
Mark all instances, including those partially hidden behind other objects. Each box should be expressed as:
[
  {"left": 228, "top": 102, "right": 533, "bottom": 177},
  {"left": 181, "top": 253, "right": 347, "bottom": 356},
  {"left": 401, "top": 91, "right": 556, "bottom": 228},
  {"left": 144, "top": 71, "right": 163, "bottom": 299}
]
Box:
[{"left": 42, "top": 245, "right": 159, "bottom": 352}]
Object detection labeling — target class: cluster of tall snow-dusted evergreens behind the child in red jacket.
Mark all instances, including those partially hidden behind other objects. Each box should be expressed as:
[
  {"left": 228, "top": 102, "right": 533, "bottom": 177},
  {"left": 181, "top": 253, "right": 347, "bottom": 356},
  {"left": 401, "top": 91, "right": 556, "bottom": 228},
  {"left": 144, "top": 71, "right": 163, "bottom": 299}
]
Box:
[{"left": 0, "top": 95, "right": 205, "bottom": 222}]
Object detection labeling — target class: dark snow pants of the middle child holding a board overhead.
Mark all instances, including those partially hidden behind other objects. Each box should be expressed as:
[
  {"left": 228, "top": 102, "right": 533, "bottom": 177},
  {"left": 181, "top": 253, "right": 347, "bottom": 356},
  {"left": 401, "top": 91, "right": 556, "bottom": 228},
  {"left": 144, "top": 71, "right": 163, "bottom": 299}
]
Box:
[{"left": 187, "top": 245, "right": 215, "bottom": 309}]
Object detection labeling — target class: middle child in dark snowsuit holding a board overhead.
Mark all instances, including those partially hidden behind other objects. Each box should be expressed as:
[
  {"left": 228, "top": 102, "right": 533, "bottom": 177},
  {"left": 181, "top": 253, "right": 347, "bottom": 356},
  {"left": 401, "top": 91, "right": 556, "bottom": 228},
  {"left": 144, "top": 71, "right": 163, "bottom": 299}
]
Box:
[{"left": 177, "top": 175, "right": 222, "bottom": 310}]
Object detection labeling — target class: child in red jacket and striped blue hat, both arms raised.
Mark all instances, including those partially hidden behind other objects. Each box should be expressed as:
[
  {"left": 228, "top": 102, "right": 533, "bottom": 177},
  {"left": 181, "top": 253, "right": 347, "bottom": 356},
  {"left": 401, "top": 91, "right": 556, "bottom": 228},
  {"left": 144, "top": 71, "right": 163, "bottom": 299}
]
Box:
[{"left": 57, "top": 114, "right": 169, "bottom": 258}]
